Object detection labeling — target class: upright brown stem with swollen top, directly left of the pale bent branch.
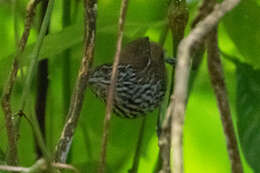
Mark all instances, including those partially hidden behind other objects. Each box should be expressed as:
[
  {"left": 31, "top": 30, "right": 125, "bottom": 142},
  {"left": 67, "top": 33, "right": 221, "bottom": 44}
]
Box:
[{"left": 159, "top": 0, "right": 189, "bottom": 173}]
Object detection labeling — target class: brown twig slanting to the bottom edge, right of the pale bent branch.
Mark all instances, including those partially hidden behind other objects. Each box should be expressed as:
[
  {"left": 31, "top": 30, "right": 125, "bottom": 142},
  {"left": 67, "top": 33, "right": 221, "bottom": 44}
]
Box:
[{"left": 207, "top": 28, "right": 243, "bottom": 173}]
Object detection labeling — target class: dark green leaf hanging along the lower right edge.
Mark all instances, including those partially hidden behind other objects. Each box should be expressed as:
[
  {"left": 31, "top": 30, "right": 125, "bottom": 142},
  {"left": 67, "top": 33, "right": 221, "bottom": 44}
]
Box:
[{"left": 235, "top": 61, "right": 260, "bottom": 172}]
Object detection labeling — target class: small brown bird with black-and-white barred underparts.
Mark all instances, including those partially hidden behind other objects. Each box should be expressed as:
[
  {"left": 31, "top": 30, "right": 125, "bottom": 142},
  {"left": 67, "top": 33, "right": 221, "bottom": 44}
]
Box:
[{"left": 88, "top": 37, "right": 167, "bottom": 118}]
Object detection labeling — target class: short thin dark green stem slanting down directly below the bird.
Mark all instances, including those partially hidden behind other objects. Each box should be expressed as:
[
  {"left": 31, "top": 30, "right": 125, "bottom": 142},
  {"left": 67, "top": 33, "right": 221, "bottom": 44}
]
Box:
[{"left": 128, "top": 117, "right": 146, "bottom": 173}]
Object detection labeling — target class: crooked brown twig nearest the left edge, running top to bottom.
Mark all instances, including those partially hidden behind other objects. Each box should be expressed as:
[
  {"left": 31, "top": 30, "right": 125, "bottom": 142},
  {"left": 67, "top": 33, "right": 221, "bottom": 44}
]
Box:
[{"left": 1, "top": 0, "right": 40, "bottom": 165}]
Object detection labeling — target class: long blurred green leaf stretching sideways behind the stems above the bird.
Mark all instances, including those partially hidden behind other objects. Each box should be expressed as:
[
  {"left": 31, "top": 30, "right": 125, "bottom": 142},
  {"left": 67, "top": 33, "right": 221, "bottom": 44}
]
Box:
[{"left": 0, "top": 20, "right": 166, "bottom": 64}]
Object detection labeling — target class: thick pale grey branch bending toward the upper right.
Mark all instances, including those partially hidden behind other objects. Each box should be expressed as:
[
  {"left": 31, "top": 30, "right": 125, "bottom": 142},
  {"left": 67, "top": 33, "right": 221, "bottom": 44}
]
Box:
[{"left": 168, "top": 0, "right": 239, "bottom": 173}]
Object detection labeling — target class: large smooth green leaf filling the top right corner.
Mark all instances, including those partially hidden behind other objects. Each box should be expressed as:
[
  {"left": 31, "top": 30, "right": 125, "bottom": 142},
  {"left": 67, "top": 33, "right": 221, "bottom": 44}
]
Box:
[{"left": 223, "top": 0, "right": 260, "bottom": 68}]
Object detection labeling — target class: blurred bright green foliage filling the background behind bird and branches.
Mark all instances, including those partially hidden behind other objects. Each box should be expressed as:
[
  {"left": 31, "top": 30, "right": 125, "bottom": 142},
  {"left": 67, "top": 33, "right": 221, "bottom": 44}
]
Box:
[{"left": 0, "top": 0, "right": 260, "bottom": 173}]
